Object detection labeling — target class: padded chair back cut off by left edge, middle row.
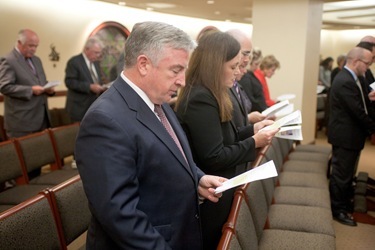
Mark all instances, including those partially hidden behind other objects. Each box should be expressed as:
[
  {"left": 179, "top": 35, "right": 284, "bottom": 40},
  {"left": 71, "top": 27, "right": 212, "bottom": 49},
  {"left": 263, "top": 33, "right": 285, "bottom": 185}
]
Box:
[{"left": 0, "top": 140, "right": 23, "bottom": 183}]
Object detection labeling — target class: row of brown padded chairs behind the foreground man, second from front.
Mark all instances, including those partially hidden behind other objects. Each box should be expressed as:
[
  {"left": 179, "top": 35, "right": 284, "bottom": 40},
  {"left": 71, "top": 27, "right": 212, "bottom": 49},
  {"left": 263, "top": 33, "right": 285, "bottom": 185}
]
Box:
[{"left": 0, "top": 123, "right": 79, "bottom": 212}]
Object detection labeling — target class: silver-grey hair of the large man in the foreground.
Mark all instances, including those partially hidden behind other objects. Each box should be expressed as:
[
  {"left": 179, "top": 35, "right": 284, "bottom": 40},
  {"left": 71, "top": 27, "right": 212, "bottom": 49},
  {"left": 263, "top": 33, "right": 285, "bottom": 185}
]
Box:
[{"left": 125, "top": 22, "right": 195, "bottom": 68}]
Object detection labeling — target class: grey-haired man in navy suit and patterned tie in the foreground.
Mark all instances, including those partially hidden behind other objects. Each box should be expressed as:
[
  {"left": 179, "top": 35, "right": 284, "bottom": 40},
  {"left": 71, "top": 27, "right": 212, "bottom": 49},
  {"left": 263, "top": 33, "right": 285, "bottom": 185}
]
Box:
[{"left": 75, "top": 22, "right": 225, "bottom": 249}]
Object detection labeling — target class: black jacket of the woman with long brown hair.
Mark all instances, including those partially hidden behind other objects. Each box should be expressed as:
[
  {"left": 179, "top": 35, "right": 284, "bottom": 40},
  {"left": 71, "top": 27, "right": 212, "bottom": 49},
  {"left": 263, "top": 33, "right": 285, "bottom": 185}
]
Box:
[{"left": 176, "top": 86, "right": 255, "bottom": 178}]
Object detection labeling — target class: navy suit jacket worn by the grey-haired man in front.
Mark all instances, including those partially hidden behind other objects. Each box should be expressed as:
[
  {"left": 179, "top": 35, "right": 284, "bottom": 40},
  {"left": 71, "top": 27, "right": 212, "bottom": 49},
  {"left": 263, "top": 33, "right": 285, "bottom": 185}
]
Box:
[{"left": 75, "top": 77, "right": 203, "bottom": 249}]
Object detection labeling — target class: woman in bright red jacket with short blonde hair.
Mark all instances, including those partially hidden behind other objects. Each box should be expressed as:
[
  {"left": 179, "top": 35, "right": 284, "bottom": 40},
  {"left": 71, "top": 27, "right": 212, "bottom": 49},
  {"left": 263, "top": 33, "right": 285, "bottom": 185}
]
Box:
[{"left": 254, "top": 55, "right": 280, "bottom": 107}]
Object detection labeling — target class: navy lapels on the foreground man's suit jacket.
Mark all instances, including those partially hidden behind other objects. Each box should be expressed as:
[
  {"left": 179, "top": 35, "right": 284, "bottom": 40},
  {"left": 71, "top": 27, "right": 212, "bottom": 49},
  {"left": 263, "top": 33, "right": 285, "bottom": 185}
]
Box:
[{"left": 113, "top": 77, "right": 193, "bottom": 176}]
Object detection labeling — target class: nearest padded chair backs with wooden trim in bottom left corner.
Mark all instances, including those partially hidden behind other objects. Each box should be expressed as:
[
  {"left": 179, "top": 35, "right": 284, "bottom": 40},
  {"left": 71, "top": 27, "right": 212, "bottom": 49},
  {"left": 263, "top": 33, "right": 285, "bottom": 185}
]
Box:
[{"left": 0, "top": 175, "right": 91, "bottom": 250}]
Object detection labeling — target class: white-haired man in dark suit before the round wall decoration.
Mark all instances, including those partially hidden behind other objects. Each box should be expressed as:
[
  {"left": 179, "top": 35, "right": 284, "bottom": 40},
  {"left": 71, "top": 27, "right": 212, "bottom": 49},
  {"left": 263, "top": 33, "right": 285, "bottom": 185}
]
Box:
[{"left": 65, "top": 37, "right": 106, "bottom": 122}]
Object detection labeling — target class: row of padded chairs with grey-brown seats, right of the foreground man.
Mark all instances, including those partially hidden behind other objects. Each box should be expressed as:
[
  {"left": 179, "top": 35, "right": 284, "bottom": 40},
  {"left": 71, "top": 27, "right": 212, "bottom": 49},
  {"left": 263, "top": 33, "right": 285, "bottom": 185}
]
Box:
[{"left": 218, "top": 138, "right": 335, "bottom": 250}]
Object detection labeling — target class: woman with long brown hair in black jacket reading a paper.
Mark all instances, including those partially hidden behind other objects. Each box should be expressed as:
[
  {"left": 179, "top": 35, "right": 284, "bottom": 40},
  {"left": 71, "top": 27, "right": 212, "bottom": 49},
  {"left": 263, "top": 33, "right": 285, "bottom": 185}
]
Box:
[{"left": 175, "top": 31, "right": 278, "bottom": 249}]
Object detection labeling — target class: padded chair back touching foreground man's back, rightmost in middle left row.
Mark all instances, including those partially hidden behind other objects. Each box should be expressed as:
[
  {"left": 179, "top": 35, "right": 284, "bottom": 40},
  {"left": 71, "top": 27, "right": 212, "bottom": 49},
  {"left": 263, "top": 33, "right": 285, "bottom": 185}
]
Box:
[{"left": 49, "top": 123, "right": 79, "bottom": 167}]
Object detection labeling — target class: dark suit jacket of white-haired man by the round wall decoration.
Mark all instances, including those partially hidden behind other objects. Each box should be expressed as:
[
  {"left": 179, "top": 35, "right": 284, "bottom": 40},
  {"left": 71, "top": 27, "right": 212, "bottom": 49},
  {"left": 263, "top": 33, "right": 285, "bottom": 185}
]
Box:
[{"left": 65, "top": 54, "right": 104, "bottom": 121}]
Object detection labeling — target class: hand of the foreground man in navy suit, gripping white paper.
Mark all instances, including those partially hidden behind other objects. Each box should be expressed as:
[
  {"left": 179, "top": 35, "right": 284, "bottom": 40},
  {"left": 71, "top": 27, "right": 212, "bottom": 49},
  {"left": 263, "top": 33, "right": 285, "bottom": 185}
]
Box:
[{"left": 198, "top": 175, "right": 227, "bottom": 202}]
